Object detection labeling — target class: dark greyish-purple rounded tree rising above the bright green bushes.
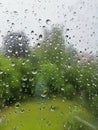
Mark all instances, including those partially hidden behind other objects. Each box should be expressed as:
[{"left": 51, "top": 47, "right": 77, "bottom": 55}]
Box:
[{"left": 3, "top": 32, "right": 30, "bottom": 57}]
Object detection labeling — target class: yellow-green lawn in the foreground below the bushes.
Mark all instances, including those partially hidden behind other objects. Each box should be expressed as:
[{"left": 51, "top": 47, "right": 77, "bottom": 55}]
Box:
[{"left": 0, "top": 98, "right": 97, "bottom": 130}]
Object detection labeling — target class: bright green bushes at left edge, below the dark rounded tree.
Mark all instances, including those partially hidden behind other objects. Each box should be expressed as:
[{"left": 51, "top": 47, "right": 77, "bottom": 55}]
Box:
[{"left": 0, "top": 55, "right": 34, "bottom": 106}]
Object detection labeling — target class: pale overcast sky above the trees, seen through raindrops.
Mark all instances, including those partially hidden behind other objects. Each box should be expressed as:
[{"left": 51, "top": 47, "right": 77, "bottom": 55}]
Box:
[{"left": 0, "top": 0, "right": 98, "bottom": 53}]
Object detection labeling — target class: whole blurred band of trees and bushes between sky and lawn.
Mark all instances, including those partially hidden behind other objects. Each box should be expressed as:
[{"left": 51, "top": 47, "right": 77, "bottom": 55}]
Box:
[{"left": 0, "top": 28, "right": 98, "bottom": 116}]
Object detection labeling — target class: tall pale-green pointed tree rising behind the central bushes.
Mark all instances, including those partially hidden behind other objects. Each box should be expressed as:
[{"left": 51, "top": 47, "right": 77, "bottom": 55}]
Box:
[{"left": 32, "top": 28, "right": 76, "bottom": 69}]
